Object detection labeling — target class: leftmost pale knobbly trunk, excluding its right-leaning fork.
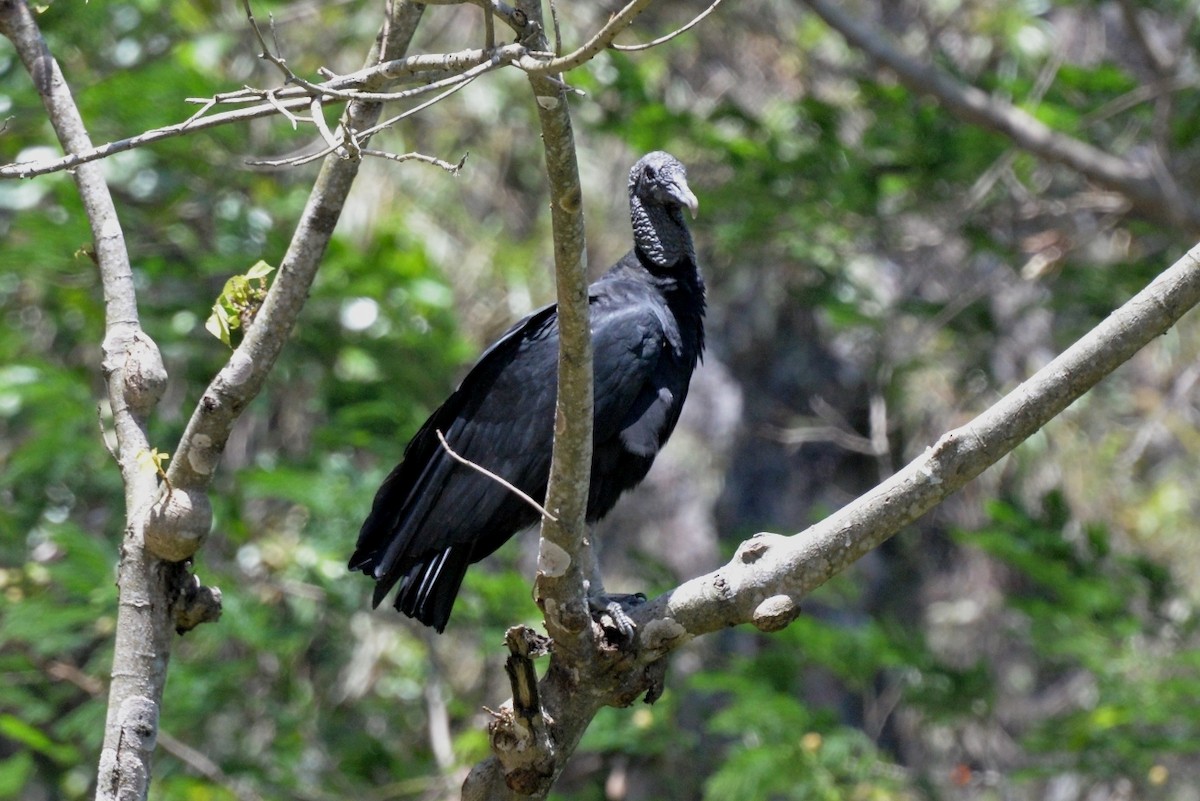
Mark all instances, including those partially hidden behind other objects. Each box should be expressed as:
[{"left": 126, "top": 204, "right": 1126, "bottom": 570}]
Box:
[{"left": 0, "top": 1, "right": 174, "bottom": 799}]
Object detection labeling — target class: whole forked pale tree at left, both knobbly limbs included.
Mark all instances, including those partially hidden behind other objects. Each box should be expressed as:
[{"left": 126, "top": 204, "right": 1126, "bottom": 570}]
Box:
[{"left": 0, "top": 1, "right": 421, "bottom": 800}]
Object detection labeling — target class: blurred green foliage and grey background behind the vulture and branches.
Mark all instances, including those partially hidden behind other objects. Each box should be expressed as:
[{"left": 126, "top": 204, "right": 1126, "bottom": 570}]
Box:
[{"left": 0, "top": 0, "right": 1200, "bottom": 801}]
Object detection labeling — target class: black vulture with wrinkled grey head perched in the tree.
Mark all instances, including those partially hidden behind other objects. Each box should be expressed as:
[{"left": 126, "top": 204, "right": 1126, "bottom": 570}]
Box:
[{"left": 349, "top": 151, "right": 704, "bottom": 632}]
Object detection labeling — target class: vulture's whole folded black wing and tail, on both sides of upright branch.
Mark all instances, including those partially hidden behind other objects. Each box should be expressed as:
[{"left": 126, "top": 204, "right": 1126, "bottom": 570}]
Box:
[{"left": 350, "top": 286, "right": 671, "bottom": 631}]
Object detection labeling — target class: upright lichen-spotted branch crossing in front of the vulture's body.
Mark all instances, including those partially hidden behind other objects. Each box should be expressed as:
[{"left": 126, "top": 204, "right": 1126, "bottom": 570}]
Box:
[{"left": 463, "top": 0, "right": 600, "bottom": 800}]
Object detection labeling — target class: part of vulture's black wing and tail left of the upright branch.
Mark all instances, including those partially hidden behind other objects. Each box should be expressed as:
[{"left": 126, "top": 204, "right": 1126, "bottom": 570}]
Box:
[{"left": 350, "top": 306, "right": 558, "bottom": 631}]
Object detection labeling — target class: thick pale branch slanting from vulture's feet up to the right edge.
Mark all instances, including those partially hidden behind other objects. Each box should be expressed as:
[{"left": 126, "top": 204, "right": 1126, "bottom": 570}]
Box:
[{"left": 463, "top": 239, "right": 1200, "bottom": 801}]
